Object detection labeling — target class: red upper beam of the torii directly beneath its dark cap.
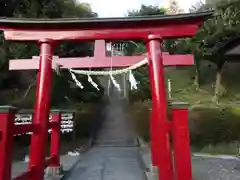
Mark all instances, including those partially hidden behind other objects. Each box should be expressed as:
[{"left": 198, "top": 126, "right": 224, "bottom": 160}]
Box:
[{"left": 4, "top": 22, "right": 199, "bottom": 41}]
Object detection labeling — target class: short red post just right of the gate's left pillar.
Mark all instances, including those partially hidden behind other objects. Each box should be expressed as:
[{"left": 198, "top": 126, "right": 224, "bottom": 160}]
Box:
[{"left": 50, "top": 111, "right": 61, "bottom": 167}]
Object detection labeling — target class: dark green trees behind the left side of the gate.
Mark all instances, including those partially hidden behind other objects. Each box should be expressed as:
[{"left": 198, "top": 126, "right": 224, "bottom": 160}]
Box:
[{"left": 0, "top": 0, "right": 103, "bottom": 106}]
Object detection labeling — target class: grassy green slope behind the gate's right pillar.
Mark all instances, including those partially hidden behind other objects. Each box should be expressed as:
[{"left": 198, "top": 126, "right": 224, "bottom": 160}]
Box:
[{"left": 165, "top": 62, "right": 240, "bottom": 106}]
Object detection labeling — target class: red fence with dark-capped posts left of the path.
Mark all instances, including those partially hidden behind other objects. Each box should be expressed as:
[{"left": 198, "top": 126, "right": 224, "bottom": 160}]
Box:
[{"left": 0, "top": 106, "right": 74, "bottom": 180}]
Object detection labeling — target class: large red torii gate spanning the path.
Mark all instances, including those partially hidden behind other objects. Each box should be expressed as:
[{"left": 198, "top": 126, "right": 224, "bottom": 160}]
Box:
[{"left": 0, "top": 12, "right": 212, "bottom": 180}]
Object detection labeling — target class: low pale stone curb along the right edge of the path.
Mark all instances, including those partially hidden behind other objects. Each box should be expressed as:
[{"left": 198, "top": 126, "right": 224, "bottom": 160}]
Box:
[{"left": 137, "top": 137, "right": 158, "bottom": 180}]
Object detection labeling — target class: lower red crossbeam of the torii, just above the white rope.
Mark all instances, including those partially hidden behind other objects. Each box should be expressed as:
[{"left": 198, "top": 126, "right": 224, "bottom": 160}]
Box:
[{"left": 9, "top": 54, "right": 194, "bottom": 70}]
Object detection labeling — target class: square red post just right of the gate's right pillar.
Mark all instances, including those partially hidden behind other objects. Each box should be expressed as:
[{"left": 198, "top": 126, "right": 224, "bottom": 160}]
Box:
[{"left": 172, "top": 109, "right": 192, "bottom": 180}]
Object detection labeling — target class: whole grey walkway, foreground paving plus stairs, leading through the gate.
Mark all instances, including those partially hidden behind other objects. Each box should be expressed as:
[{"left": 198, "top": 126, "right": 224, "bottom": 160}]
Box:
[{"left": 66, "top": 97, "right": 146, "bottom": 180}]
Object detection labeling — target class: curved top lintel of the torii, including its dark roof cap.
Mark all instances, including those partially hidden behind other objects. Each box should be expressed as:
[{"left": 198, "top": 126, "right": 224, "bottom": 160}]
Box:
[{"left": 0, "top": 11, "right": 212, "bottom": 41}]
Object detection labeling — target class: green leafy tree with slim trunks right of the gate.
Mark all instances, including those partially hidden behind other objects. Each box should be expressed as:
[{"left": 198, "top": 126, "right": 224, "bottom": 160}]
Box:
[{"left": 171, "top": 0, "right": 240, "bottom": 102}]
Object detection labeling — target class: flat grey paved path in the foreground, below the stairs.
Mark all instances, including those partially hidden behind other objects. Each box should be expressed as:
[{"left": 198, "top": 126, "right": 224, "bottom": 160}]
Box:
[{"left": 63, "top": 147, "right": 145, "bottom": 180}]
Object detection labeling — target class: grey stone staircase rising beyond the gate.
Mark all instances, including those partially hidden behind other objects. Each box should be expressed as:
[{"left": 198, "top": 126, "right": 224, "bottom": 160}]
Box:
[{"left": 94, "top": 100, "right": 137, "bottom": 147}]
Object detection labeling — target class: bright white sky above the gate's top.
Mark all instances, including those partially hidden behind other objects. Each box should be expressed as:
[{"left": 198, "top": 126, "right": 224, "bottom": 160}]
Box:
[{"left": 78, "top": 0, "right": 200, "bottom": 17}]
